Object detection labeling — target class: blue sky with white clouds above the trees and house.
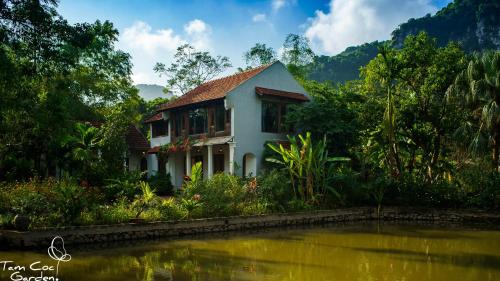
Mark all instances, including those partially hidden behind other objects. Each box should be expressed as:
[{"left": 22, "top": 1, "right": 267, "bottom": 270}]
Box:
[{"left": 58, "top": 0, "right": 451, "bottom": 86}]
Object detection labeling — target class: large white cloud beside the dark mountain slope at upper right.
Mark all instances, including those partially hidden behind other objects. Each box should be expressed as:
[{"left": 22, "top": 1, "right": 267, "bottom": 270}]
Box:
[{"left": 305, "top": 0, "right": 437, "bottom": 55}]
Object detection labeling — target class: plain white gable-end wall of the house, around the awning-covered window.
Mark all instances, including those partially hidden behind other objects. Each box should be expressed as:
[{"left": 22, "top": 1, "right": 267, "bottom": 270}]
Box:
[{"left": 226, "top": 62, "right": 308, "bottom": 176}]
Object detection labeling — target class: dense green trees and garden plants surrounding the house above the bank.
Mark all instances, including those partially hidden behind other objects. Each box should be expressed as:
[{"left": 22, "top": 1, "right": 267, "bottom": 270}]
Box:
[{"left": 0, "top": 0, "right": 500, "bottom": 228}]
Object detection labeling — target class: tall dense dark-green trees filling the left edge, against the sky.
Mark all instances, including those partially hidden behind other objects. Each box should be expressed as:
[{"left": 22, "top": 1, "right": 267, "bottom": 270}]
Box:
[{"left": 0, "top": 0, "right": 137, "bottom": 180}]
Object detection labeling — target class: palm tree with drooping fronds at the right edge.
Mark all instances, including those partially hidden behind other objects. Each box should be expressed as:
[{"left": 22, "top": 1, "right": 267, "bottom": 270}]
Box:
[{"left": 448, "top": 51, "right": 500, "bottom": 172}]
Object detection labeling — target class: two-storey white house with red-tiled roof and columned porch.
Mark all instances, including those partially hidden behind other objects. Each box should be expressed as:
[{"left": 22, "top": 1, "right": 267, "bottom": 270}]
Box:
[{"left": 145, "top": 61, "right": 309, "bottom": 187}]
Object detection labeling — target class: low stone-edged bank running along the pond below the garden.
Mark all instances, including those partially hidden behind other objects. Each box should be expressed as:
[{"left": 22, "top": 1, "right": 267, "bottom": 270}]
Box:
[{"left": 0, "top": 207, "right": 500, "bottom": 249}]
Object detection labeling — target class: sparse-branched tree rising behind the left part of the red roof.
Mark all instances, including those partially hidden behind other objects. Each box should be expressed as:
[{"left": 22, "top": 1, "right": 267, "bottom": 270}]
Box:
[{"left": 154, "top": 44, "right": 231, "bottom": 94}]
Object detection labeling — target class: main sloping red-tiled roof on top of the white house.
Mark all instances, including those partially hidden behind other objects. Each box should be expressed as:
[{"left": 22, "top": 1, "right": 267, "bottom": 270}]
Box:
[{"left": 156, "top": 64, "right": 271, "bottom": 111}]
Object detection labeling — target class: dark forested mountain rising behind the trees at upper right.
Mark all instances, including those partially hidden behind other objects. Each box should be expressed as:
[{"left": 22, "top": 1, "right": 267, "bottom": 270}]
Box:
[{"left": 308, "top": 0, "right": 500, "bottom": 83}]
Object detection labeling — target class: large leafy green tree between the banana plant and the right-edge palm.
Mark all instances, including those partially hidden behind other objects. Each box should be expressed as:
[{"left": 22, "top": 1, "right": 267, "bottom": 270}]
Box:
[{"left": 361, "top": 33, "right": 465, "bottom": 182}]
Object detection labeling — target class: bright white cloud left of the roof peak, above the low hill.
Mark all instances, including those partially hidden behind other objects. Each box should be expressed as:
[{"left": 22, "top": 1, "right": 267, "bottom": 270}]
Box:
[{"left": 118, "top": 19, "right": 212, "bottom": 85}]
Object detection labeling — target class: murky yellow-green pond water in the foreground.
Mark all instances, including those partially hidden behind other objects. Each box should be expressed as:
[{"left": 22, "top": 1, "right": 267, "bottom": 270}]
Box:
[{"left": 0, "top": 225, "right": 500, "bottom": 281}]
